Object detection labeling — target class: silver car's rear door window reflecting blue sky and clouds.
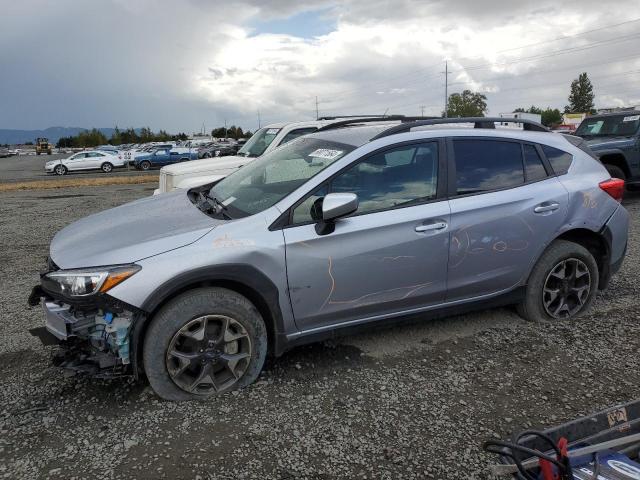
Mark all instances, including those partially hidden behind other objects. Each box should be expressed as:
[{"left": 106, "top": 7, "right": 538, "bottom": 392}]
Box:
[{"left": 453, "top": 140, "right": 525, "bottom": 195}]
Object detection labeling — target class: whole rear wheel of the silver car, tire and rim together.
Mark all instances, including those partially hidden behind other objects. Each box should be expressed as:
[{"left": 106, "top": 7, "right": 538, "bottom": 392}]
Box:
[{"left": 518, "top": 240, "right": 599, "bottom": 321}]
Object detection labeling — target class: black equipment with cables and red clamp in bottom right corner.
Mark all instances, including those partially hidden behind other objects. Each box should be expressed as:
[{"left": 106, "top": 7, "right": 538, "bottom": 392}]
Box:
[{"left": 484, "top": 400, "right": 640, "bottom": 480}]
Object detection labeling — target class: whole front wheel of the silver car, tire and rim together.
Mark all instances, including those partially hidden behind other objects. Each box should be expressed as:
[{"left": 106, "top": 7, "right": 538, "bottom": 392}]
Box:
[{"left": 143, "top": 288, "right": 267, "bottom": 401}]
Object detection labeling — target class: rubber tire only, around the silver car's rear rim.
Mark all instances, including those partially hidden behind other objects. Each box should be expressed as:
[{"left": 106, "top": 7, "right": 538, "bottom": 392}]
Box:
[{"left": 517, "top": 240, "right": 599, "bottom": 322}]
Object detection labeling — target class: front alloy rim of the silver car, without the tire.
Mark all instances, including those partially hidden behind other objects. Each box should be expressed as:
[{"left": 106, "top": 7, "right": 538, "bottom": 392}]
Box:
[{"left": 166, "top": 315, "right": 252, "bottom": 395}]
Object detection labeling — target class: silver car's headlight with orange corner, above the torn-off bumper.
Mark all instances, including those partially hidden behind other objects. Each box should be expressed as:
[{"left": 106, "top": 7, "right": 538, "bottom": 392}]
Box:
[{"left": 41, "top": 265, "right": 141, "bottom": 297}]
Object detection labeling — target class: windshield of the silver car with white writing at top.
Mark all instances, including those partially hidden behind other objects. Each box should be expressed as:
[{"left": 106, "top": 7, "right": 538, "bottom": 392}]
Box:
[{"left": 209, "top": 137, "right": 355, "bottom": 218}]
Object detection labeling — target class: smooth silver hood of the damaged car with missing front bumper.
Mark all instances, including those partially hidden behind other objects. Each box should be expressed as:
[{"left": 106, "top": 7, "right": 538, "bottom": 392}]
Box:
[{"left": 50, "top": 190, "right": 224, "bottom": 269}]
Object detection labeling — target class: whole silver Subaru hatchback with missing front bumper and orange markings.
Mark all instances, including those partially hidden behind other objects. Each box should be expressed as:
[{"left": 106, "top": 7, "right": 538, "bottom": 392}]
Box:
[{"left": 30, "top": 118, "right": 629, "bottom": 400}]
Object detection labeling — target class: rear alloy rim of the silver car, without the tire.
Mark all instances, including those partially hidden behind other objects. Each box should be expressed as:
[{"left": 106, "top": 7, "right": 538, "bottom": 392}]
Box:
[{"left": 542, "top": 258, "right": 591, "bottom": 318}]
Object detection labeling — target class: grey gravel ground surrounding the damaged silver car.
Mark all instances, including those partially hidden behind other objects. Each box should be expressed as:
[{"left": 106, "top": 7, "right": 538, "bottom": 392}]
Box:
[{"left": 0, "top": 186, "right": 640, "bottom": 480}]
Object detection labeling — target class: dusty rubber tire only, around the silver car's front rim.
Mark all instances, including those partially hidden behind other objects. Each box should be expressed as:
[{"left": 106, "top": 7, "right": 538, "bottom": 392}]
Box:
[{"left": 143, "top": 288, "right": 267, "bottom": 401}]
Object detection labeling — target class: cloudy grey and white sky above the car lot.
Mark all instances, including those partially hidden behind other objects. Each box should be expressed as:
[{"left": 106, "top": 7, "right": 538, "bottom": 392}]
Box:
[{"left": 0, "top": 0, "right": 640, "bottom": 132}]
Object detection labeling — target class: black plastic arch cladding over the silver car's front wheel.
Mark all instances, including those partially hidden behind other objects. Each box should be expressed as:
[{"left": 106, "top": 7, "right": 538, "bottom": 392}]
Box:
[{"left": 132, "top": 264, "right": 285, "bottom": 373}]
